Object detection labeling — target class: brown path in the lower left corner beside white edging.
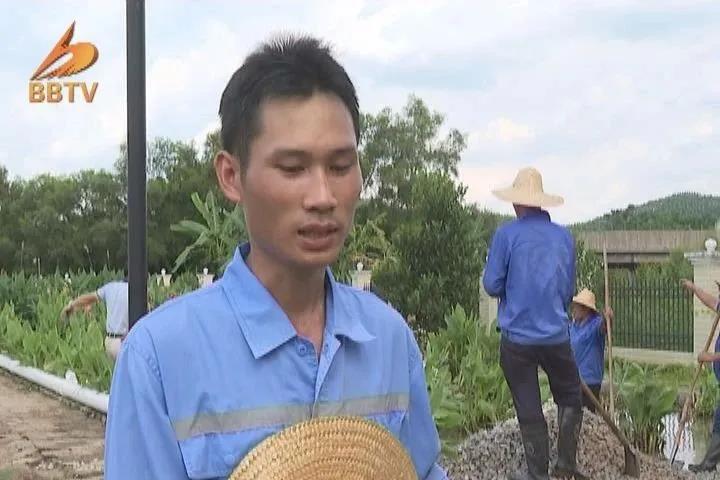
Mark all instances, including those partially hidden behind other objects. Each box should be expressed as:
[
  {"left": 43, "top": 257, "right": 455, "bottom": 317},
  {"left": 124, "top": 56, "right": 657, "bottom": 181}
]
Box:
[{"left": 0, "top": 368, "right": 105, "bottom": 480}]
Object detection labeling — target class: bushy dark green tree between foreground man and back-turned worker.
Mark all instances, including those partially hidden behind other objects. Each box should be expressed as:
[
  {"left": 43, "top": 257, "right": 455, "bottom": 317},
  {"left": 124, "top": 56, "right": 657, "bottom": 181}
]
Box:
[{"left": 373, "top": 172, "right": 482, "bottom": 331}]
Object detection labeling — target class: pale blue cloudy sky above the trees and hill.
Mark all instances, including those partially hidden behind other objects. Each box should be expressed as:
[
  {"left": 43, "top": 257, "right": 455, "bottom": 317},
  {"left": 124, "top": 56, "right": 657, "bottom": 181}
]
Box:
[{"left": 0, "top": 0, "right": 720, "bottom": 223}]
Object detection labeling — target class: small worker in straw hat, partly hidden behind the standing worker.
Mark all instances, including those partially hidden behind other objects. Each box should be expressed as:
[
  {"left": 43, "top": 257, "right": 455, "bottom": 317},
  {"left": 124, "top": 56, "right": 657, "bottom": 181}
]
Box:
[{"left": 570, "top": 288, "right": 613, "bottom": 413}]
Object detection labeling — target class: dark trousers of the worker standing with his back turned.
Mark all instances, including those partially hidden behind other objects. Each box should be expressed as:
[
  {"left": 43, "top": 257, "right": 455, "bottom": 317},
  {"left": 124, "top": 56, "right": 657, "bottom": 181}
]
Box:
[{"left": 500, "top": 338, "right": 582, "bottom": 425}]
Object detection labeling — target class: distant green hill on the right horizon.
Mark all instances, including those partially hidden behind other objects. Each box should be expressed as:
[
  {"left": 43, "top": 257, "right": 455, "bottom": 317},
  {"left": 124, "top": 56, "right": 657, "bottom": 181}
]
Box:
[{"left": 571, "top": 193, "right": 720, "bottom": 231}]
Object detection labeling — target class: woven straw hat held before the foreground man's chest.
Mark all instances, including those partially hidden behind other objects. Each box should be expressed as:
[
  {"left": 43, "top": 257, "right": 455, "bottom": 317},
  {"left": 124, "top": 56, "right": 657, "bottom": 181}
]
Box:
[{"left": 229, "top": 416, "right": 417, "bottom": 480}]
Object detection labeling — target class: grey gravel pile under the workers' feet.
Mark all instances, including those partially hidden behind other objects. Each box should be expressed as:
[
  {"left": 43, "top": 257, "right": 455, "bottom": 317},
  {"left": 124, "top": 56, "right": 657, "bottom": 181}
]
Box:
[{"left": 444, "top": 406, "right": 720, "bottom": 480}]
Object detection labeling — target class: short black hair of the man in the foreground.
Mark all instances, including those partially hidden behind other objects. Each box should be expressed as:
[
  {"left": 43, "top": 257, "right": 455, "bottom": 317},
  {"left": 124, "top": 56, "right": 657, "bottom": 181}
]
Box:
[{"left": 219, "top": 35, "right": 360, "bottom": 170}]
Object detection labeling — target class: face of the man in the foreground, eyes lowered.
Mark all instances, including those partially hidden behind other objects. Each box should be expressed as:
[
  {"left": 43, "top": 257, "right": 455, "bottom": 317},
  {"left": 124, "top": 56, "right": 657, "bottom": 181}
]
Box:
[{"left": 229, "top": 93, "right": 362, "bottom": 268}]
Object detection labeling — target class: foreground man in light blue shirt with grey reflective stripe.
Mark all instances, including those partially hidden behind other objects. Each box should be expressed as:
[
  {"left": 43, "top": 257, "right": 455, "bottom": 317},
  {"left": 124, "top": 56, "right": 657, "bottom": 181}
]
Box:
[{"left": 105, "top": 37, "right": 446, "bottom": 480}]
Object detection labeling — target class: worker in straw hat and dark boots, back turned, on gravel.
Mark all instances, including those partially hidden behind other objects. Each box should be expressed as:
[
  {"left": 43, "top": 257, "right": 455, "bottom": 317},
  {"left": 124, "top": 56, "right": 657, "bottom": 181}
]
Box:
[{"left": 483, "top": 168, "right": 584, "bottom": 480}]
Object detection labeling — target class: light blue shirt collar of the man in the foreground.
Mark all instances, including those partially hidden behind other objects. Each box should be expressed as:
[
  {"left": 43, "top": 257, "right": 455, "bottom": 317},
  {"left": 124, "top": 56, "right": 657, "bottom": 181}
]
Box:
[{"left": 220, "top": 243, "right": 375, "bottom": 359}]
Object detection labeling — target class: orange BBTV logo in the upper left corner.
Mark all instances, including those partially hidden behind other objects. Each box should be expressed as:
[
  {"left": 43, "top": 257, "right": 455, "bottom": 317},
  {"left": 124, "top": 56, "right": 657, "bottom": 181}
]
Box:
[{"left": 28, "top": 22, "right": 98, "bottom": 103}]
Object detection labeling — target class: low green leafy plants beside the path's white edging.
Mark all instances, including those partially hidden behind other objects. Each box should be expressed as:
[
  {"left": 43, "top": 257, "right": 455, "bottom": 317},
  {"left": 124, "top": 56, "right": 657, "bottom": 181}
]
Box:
[{"left": 0, "top": 271, "right": 197, "bottom": 391}]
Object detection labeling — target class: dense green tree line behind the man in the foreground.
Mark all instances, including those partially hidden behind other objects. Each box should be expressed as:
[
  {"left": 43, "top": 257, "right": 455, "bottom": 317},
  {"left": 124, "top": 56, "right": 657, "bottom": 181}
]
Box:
[{"left": 0, "top": 97, "right": 506, "bottom": 329}]
